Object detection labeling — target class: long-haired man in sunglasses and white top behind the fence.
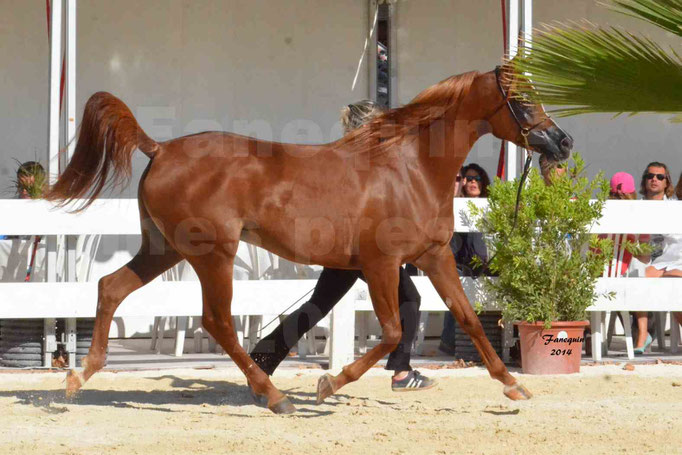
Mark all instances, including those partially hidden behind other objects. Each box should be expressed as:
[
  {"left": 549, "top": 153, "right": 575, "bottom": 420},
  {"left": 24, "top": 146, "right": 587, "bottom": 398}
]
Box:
[{"left": 635, "top": 161, "right": 682, "bottom": 354}]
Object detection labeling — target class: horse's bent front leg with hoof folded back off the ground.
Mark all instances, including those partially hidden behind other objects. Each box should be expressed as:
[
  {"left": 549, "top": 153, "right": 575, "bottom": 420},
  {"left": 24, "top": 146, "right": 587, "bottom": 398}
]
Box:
[{"left": 317, "top": 261, "right": 402, "bottom": 404}]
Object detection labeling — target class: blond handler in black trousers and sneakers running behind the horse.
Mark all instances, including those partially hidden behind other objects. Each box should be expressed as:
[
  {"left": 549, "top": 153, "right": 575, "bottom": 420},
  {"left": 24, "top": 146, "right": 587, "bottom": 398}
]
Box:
[{"left": 251, "top": 101, "right": 435, "bottom": 391}]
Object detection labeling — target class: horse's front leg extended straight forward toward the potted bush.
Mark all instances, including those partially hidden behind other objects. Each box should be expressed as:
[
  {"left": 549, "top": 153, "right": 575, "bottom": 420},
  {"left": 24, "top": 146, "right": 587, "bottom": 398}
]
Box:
[{"left": 415, "top": 245, "right": 532, "bottom": 400}]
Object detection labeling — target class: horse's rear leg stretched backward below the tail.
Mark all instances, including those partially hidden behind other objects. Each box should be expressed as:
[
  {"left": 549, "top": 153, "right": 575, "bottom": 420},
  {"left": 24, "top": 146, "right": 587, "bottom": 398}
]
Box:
[{"left": 66, "top": 219, "right": 182, "bottom": 397}]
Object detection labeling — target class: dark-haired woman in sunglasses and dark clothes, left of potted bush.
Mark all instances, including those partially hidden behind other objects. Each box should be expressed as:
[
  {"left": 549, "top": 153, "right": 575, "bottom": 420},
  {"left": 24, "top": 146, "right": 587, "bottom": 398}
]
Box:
[{"left": 439, "top": 163, "right": 490, "bottom": 355}]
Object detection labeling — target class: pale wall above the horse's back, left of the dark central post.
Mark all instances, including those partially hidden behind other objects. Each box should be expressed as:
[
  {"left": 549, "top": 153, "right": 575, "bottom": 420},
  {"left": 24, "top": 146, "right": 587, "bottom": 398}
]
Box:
[{"left": 0, "top": 0, "right": 368, "bottom": 197}]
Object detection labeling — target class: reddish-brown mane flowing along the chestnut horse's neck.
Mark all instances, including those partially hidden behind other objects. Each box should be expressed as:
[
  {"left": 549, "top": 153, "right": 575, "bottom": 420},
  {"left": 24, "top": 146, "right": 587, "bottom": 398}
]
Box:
[{"left": 336, "top": 71, "right": 479, "bottom": 156}]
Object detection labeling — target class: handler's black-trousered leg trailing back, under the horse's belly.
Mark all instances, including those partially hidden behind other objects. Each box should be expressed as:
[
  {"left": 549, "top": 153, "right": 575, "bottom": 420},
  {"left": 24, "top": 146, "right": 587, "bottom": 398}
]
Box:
[{"left": 251, "top": 268, "right": 362, "bottom": 375}]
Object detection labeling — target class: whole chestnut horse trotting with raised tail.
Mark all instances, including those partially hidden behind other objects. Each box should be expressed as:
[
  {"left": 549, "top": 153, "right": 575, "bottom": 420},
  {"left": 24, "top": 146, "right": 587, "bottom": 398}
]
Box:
[{"left": 47, "top": 67, "right": 572, "bottom": 413}]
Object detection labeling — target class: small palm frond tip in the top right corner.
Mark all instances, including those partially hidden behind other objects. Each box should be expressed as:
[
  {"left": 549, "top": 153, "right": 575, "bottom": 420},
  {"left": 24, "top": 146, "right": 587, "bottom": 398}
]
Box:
[{"left": 601, "top": 0, "right": 682, "bottom": 36}]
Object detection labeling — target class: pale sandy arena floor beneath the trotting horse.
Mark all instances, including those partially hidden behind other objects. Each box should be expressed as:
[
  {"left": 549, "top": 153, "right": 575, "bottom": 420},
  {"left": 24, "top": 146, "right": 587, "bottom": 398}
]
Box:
[{"left": 0, "top": 364, "right": 682, "bottom": 455}]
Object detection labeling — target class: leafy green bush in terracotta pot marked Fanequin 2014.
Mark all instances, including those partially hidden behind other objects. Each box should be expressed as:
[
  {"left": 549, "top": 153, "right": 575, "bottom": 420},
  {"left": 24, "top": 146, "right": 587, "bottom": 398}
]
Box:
[{"left": 469, "top": 155, "right": 612, "bottom": 374}]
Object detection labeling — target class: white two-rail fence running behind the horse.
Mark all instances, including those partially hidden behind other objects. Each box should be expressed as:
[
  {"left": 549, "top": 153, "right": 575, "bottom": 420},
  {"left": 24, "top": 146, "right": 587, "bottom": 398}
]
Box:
[{"left": 0, "top": 199, "right": 682, "bottom": 369}]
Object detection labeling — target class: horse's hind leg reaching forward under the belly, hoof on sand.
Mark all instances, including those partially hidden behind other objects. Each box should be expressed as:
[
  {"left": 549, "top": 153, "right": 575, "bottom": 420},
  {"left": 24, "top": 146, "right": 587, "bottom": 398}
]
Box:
[{"left": 187, "top": 251, "right": 296, "bottom": 414}]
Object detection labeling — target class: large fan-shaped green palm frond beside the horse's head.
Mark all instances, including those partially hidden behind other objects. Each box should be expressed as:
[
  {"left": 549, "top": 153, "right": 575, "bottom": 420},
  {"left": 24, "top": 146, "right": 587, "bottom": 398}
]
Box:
[{"left": 511, "top": 23, "right": 682, "bottom": 116}]
